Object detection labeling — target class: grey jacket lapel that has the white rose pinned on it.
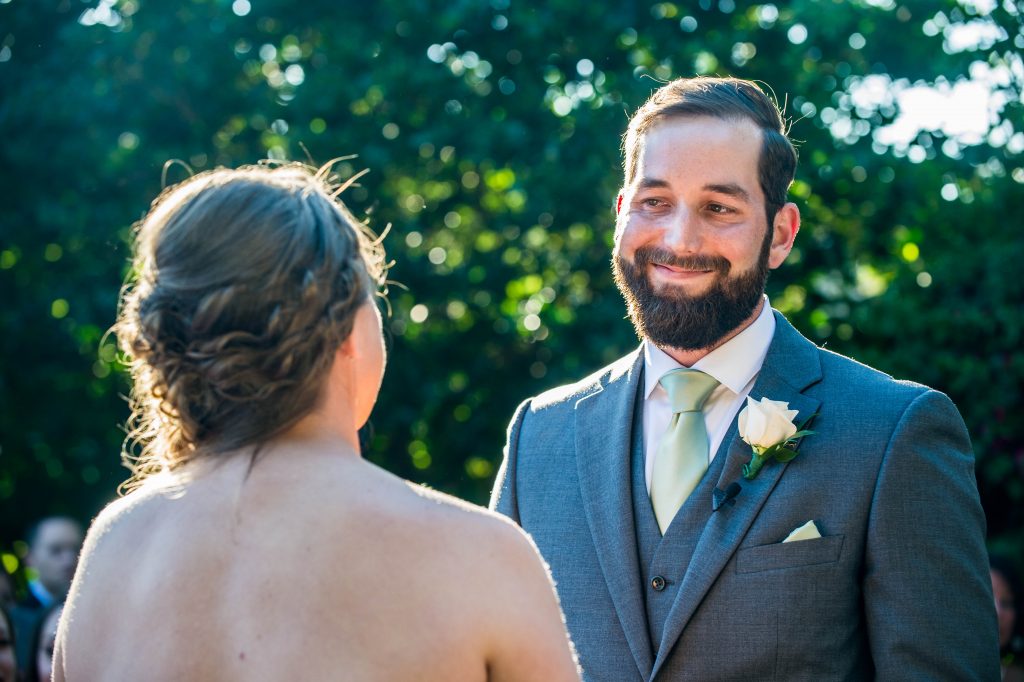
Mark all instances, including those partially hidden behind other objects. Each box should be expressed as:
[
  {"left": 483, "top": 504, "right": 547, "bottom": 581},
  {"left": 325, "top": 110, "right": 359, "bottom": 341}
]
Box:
[{"left": 651, "top": 312, "right": 821, "bottom": 679}]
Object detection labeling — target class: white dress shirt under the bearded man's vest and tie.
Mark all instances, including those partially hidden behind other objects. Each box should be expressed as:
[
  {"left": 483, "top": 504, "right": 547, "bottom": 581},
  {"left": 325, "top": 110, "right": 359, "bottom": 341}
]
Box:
[{"left": 643, "top": 297, "right": 775, "bottom": 493}]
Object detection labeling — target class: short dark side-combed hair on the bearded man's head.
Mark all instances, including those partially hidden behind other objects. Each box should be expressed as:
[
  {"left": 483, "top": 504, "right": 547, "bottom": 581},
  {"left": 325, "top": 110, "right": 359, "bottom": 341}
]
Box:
[{"left": 623, "top": 76, "right": 797, "bottom": 228}]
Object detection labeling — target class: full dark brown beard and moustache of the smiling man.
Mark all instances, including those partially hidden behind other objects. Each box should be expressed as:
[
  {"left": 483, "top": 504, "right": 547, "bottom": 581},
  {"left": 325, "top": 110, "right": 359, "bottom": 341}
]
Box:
[{"left": 612, "top": 235, "right": 771, "bottom": 350}]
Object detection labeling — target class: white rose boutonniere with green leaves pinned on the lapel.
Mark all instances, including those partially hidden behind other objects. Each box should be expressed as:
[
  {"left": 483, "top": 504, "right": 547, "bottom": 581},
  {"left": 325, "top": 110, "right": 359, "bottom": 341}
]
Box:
[{"left": 738, "top": 396, "right": 814, "bottom": 480}]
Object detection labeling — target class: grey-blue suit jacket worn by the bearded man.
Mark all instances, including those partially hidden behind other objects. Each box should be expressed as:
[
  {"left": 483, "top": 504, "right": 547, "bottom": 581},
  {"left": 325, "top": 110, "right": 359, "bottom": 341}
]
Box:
[{"left": 492, "top": 312, "right": 999, "bottom": 682}]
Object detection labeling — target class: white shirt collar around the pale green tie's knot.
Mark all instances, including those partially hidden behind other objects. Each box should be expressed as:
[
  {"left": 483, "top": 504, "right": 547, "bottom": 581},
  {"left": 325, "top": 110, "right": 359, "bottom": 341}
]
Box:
[{"left": 643, "top": 296, "right": 775, "bottom": 398}]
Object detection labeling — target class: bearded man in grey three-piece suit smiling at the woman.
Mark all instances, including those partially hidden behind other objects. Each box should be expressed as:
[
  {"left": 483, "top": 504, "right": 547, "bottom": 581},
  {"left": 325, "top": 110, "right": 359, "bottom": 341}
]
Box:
[{"left": 492, "top": 78, "right": 999, "bottom": 682}]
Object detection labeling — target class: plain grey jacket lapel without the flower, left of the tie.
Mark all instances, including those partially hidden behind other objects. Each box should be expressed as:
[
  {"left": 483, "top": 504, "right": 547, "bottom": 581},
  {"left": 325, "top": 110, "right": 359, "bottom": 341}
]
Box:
[{"left": 575, "top": 351, "right": 652, "bottom": 679}]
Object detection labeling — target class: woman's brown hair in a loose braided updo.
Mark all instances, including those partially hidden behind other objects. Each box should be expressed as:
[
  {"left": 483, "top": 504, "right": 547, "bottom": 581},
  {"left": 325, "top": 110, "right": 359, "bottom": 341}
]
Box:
[{"left": 114, "top": 164, "right": 386, "bottom": 486}]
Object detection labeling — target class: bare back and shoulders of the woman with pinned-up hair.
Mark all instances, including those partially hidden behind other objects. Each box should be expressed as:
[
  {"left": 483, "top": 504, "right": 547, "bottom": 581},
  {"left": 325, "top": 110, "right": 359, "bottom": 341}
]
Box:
[{"left": 58, "top": 442, "right": 575, "bottom": 681}]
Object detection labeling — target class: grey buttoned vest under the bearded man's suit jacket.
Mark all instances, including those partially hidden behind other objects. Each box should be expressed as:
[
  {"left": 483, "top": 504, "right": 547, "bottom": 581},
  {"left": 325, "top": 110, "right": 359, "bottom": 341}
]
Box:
[{"left": 631, "top": 378, "right": 726, "bottom": 656}]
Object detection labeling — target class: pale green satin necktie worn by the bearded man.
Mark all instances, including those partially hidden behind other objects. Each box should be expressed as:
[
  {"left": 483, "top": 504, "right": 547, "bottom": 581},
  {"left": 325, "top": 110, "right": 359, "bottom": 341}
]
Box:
[{"left": 650, "top": 369, "right": 718, "bottom": 535}]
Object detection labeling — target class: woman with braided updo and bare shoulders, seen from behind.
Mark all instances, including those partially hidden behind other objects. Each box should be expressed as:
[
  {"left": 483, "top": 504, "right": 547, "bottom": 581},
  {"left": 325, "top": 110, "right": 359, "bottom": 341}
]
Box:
[{"left": 54, "top": 165, "right": 579, "bottom": 681}]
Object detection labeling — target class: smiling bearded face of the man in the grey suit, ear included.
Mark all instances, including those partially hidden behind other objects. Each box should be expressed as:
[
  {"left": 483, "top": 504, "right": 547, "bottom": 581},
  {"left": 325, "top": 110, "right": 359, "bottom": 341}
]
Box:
[{"left": 612, "top": 117, "right": 799, "bottom": 350}]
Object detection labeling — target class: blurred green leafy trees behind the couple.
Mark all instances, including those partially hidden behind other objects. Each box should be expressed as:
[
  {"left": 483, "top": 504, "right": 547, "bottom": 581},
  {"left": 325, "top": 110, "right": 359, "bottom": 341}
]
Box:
[{"left": 0, "top": 0, "right": 1024, "bottom": 556}]
